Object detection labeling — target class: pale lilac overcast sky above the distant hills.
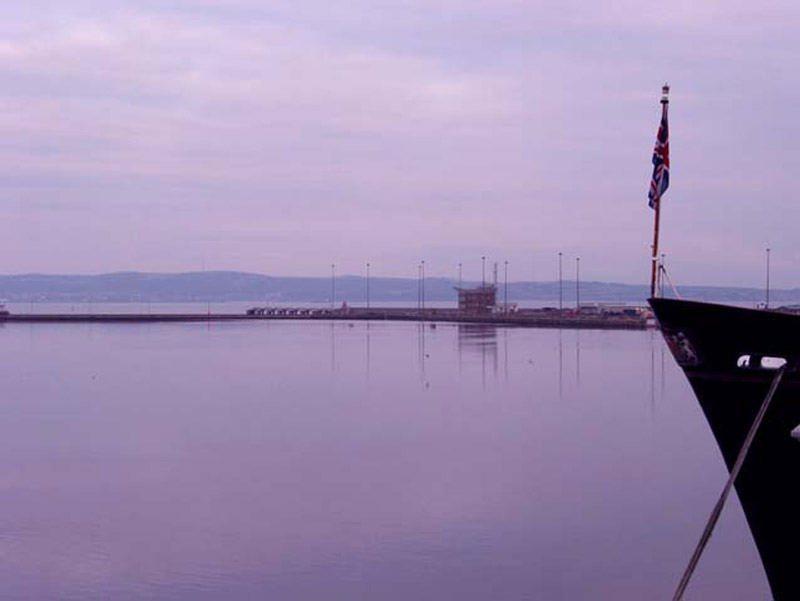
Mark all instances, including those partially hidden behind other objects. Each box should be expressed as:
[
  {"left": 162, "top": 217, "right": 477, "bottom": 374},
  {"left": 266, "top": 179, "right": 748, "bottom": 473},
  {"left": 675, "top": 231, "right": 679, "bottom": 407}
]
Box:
[{"left": 0, "top": 0, "right": 800, "bottom": 287}]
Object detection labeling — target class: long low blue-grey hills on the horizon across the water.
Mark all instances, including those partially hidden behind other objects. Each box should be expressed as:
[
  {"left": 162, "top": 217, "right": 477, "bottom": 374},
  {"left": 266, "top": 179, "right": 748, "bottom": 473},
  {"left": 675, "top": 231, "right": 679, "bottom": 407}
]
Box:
[{"left": 0, "top": 271, "right": 800, "bottom": 304}]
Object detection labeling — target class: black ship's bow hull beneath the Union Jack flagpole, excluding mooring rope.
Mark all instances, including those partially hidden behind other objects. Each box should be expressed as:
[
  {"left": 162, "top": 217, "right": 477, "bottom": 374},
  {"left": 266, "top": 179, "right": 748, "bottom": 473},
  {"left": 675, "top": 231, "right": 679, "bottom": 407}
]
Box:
[{"left": 650, "top": 299, "right": 800, "bottom": 601}]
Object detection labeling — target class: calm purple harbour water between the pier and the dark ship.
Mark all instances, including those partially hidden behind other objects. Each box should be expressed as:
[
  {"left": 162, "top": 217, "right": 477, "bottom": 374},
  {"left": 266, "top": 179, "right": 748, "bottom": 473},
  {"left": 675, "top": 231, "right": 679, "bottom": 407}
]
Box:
[{"left": 0, "top": 322, "right": 769, "bottom": 601}]
